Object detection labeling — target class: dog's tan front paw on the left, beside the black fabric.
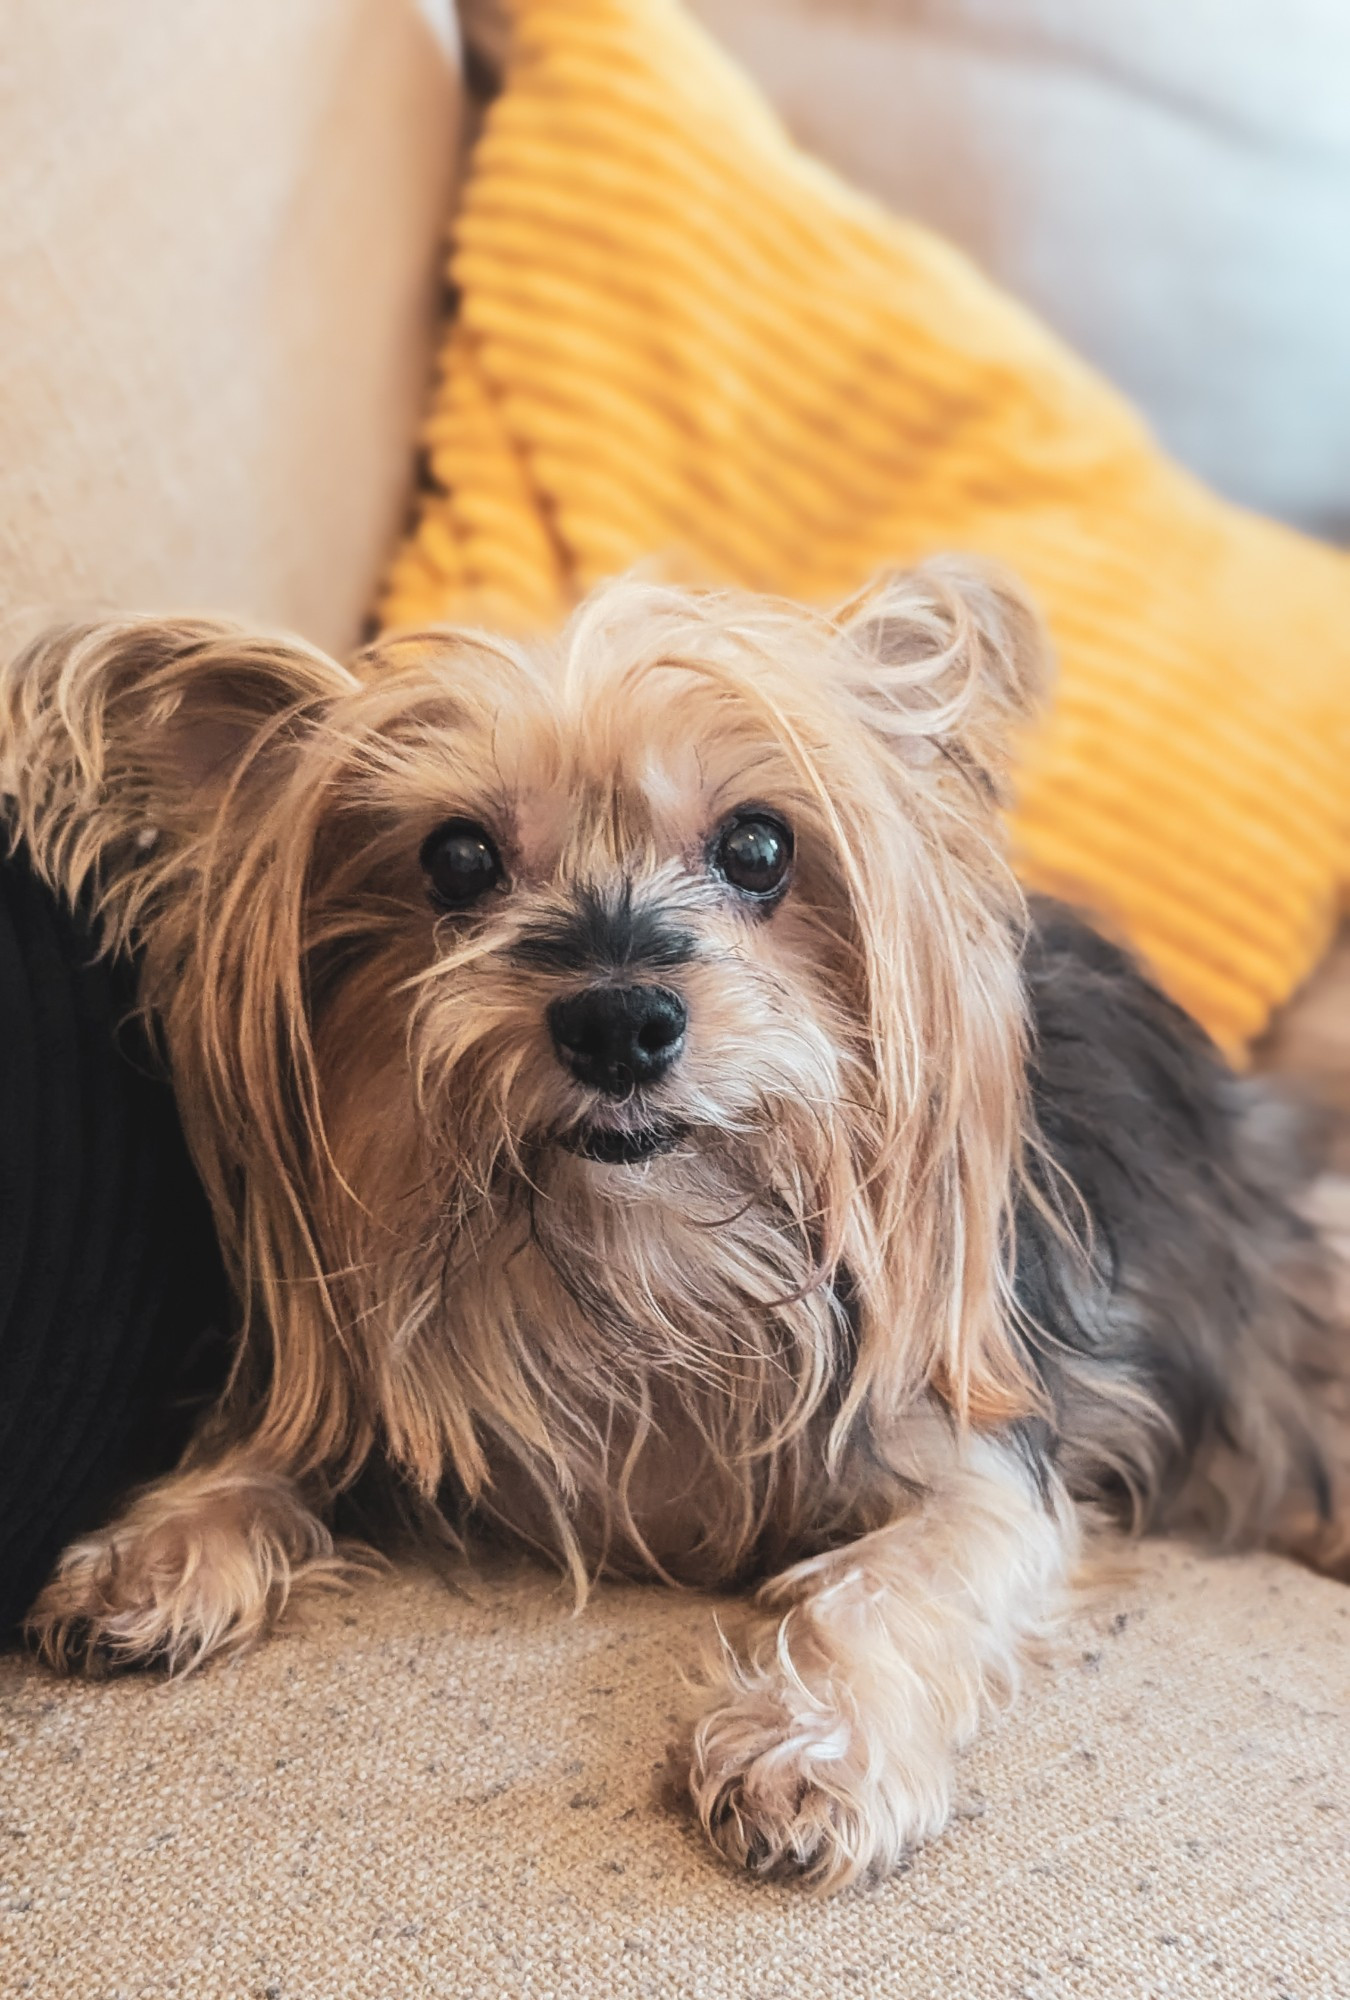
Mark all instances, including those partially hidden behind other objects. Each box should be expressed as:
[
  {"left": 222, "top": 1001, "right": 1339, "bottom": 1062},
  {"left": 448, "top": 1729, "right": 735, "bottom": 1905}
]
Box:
[{"left": 28, "top": 1452, "right": 350, "bottom": 1674}]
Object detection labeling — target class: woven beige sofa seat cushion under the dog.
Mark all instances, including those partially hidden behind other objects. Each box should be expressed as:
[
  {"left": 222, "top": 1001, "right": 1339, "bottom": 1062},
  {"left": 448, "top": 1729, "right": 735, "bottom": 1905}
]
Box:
[{"left": 0, "top": 1546, "right": 1350, "bottom": 2000}]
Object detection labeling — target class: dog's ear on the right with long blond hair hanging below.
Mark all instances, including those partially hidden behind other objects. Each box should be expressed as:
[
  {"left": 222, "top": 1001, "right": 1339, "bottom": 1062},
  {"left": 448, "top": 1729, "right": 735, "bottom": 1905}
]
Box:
[{"left": 820, "top": 562, "right": 1046, "bottom": 1428}]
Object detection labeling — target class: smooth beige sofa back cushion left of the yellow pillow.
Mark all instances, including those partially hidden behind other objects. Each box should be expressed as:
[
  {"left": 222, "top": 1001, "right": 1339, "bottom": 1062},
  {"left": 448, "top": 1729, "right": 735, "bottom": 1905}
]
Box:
[{"left": 0, "top": 0, "right": 458, "bottom": 648}]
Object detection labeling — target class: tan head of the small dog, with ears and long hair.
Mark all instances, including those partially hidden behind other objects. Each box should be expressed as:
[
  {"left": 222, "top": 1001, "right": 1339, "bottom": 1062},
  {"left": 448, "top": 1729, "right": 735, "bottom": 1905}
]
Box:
[{"left": 0, "top": 566, "right": 1040, "bottom": 1544}]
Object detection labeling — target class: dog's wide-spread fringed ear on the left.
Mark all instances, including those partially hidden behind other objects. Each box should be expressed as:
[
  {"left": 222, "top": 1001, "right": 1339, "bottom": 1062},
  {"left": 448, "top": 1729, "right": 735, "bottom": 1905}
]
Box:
[{"left": 0, "top": 618, "right": 358, "bottom": 936}]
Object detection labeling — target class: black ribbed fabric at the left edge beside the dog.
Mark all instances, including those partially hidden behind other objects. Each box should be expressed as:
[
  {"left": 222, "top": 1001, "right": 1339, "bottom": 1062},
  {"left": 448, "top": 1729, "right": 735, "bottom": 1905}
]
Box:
[{"left": 0, "top": 852, "right": 228, "bottom": 1642}]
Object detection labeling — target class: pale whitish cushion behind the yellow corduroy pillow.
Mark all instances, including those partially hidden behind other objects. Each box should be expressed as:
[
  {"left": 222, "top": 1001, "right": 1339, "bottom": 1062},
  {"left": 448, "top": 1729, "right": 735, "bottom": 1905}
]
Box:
[{"left": 694, "top": 0, "right": 1350, "bottom": 536}]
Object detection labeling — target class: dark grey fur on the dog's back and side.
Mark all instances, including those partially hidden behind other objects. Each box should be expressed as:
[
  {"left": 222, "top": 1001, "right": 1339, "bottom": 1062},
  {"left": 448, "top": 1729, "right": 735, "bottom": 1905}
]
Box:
[{"left": 1016, "top": 900, "right": 1334, "bottom": 1546}]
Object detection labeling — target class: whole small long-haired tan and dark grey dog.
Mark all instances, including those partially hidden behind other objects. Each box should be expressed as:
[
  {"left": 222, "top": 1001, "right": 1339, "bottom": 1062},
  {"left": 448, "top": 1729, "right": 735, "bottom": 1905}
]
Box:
[{"left": 0, "top": 564, "right": 1350, "bottom": 1888}]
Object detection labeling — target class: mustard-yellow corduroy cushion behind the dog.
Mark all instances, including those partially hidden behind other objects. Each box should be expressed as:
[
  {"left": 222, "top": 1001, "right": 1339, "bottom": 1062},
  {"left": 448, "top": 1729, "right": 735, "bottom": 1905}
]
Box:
[{"left": 382, "top": 0, "right": 1350, "bottom": 1048}]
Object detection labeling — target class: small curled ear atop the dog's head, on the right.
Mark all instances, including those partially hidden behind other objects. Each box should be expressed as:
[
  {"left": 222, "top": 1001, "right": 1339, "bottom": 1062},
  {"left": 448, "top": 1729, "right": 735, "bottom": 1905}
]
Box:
[{"left": 834, "top": 558, "right": 1050, "bottom": 804}]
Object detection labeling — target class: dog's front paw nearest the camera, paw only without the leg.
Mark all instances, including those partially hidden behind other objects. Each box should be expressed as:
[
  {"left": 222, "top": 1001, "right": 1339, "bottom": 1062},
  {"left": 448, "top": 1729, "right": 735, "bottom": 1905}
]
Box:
[{"left": 688, "top": 1672, "right": 950, "bottom": 1894}]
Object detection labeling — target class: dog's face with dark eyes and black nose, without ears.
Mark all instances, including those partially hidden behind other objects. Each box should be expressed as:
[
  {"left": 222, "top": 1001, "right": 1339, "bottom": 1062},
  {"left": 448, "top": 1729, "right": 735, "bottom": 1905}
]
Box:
[{"left": 328, "top": 606, "right": 888, "bottom": 1204}]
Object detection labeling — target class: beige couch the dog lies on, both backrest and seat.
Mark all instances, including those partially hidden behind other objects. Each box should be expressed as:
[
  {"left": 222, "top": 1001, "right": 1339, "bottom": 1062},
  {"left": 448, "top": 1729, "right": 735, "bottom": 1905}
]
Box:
[{"left": 0, "top": 0, "right": 1350, "bottom": 2000}]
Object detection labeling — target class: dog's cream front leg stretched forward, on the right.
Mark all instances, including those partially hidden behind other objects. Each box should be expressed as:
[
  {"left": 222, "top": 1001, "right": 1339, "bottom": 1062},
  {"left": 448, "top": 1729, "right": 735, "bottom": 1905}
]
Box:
[{"left": 690, "top": 1438, "right": 1076, "bottom": 1890}]
